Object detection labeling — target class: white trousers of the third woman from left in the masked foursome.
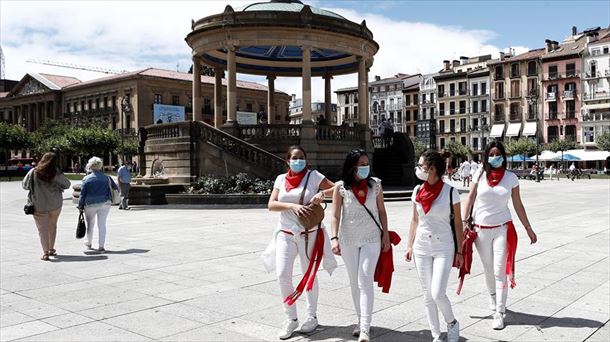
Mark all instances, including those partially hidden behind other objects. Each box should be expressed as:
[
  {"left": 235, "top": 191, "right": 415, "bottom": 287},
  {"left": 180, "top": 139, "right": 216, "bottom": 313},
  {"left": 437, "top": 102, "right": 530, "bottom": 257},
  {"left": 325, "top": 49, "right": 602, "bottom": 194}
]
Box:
[{"left": 413, "top": 249, "right": 455, "bottom": 338}]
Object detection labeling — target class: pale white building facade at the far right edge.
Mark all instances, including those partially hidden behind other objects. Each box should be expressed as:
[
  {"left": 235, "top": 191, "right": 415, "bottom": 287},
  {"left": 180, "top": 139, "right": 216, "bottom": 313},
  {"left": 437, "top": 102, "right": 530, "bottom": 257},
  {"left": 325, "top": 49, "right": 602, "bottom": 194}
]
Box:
[{"left": 581, "top": 30, "right": 610, "bottom": 148}]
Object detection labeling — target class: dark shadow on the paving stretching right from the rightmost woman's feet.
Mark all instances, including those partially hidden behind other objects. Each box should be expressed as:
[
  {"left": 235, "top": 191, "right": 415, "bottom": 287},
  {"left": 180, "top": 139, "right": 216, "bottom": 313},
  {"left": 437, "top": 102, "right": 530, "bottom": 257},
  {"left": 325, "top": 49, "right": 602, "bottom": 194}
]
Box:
[{"left": 470, "top": 310, "right": 604, "bottom": 329}]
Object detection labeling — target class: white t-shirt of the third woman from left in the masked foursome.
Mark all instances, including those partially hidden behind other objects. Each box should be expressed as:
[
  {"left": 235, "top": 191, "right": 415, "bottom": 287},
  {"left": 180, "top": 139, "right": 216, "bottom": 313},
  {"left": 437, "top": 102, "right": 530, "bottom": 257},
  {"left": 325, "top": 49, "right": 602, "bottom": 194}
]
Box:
[{"left": 411, "top": 183, "right": 460, "bottom": 254}]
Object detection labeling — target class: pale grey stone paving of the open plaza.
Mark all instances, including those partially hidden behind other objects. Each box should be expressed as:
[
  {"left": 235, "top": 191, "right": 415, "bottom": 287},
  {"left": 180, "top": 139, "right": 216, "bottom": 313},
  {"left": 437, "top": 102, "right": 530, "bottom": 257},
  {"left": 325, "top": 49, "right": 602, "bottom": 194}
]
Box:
[{"left": 0, "top": 179, "right": 610, "bottom": 341}]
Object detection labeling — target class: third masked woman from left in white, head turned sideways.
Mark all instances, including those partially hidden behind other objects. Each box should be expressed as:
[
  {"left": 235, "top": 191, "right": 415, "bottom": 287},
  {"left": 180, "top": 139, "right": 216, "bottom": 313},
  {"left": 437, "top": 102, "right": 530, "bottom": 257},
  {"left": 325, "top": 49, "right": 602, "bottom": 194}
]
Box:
[{"left": 405, "top": 150, "right": 464, "bottom": 342}]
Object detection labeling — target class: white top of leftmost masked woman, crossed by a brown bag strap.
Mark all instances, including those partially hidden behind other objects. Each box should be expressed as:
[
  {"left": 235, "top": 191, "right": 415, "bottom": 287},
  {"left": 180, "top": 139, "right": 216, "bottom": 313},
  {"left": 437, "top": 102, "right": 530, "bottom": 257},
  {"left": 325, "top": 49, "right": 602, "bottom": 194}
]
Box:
[{"left": 273, "top": 170, "right": 326, "bottom": 233}]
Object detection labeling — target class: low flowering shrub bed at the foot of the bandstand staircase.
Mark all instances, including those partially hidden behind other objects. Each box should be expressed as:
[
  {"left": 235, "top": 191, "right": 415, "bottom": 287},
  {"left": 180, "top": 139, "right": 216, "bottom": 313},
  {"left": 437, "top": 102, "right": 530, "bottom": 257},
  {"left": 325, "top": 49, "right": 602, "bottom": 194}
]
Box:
[{"left": 188, "top": 173, "right": 273, "bottom": 194}]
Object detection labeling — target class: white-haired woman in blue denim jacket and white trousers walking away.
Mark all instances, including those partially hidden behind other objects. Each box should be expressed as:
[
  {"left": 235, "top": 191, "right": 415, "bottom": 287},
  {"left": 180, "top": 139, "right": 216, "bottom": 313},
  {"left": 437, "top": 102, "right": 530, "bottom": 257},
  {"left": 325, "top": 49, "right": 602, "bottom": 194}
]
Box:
[{"left": 78, "top": 157, "right": 118, "bottom": 253}]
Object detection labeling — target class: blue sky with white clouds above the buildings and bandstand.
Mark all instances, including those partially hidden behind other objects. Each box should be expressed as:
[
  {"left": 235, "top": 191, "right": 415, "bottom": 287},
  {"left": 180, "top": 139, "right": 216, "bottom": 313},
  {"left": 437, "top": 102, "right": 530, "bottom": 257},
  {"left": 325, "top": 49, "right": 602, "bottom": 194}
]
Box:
[{"left": 0, "top": 0, "right": 610, "bottom": 100}]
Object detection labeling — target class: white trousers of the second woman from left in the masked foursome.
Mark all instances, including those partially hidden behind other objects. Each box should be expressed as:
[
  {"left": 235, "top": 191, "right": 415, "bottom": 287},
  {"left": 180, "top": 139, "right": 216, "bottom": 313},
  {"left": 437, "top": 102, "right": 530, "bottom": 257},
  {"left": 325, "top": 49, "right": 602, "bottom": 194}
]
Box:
[{"left": 341, "top": 242, "right": 381, "bottom": 331}]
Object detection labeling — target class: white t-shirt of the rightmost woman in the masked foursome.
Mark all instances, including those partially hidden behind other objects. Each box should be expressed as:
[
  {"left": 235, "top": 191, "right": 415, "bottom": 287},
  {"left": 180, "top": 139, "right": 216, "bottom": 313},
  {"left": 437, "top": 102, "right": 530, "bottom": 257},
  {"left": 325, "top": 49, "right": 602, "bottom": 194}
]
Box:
[{"left": 472, "top": 168, "right": 519, "bottom": 226}]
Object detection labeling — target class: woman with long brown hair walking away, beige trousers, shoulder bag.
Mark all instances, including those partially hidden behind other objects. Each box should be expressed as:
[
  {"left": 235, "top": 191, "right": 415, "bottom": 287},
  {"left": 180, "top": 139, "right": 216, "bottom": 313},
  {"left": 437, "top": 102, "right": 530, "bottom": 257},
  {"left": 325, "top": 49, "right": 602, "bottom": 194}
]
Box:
[{"left": 22, "top": 153, "right": 70, "bottom": 260}]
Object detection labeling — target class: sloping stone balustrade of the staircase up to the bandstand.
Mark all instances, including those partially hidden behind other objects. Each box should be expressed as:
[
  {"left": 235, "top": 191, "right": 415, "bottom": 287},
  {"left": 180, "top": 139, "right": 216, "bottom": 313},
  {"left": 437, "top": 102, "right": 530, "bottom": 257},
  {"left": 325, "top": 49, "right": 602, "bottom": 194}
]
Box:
[{"left": 195, "top": 121, "right": 286, "bottom": 173}]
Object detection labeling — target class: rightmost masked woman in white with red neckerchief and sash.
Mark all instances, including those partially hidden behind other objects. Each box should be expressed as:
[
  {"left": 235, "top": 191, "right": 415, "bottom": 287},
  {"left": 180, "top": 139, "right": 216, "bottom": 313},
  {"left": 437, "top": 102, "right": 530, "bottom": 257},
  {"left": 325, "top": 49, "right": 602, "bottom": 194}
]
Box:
[{"left": 464, "top": 141, "right": 537, "bottom": 330}]
